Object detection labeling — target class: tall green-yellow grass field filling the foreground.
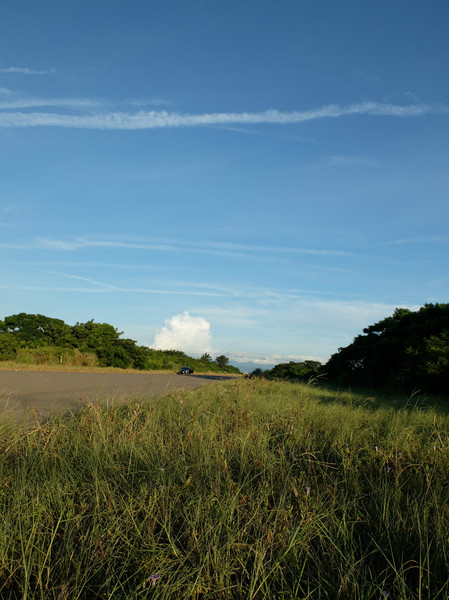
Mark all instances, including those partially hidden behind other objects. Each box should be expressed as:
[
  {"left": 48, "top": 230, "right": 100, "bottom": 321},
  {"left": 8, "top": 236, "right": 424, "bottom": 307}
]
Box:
[{"left": 0, "top": 379, "right": 449, "bottom": 600}]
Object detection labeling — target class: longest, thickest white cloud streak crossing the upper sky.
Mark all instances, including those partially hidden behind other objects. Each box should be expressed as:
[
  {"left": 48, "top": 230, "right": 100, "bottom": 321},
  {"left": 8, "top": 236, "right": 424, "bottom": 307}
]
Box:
[{"left": 0, "top": 102, "right": 442, "bottom": 130}]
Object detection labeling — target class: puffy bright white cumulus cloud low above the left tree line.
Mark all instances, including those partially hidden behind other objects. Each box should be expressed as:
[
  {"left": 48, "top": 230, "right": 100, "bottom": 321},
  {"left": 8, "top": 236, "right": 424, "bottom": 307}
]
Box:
[{"left": 152, "top": 311, "right": 212, "bottom": 354}]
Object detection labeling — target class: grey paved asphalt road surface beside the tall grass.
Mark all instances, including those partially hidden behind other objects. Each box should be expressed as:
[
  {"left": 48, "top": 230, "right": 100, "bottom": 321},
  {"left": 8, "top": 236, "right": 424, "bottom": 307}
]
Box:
[{"left": 0, "top": 370, "right": 227, "bottom": 416}]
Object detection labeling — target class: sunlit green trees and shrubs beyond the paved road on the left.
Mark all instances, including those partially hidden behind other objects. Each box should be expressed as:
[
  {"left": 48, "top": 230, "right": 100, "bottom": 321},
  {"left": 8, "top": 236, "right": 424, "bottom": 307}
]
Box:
[{"left": 0, "top": 313, "right": 240, "bottom": 373}]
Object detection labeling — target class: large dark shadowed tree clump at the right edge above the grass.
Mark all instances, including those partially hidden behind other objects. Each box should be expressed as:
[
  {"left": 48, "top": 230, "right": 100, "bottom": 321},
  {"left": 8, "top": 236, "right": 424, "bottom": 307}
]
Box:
[{"left": 323, "top": 304, "right": 449, "bottom": 392}]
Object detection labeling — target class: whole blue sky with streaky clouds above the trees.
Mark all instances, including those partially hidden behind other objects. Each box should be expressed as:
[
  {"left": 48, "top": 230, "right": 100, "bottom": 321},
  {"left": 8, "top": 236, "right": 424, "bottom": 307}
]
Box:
[{"left": 0, "top": 0, "right": 449, "bottom": 367}]
